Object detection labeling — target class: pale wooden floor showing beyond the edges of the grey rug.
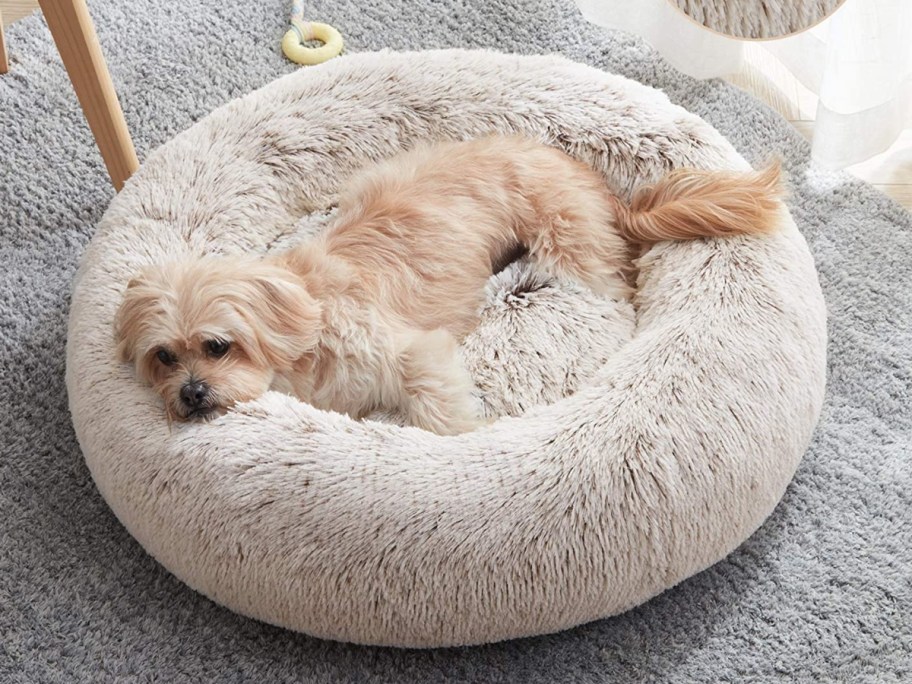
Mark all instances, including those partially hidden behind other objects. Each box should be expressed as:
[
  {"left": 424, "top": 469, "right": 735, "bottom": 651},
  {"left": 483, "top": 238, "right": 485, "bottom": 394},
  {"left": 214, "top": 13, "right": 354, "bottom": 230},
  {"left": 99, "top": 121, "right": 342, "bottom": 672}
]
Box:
[{"left": 0, "top": 0, "right": 912, "bottom": 209}]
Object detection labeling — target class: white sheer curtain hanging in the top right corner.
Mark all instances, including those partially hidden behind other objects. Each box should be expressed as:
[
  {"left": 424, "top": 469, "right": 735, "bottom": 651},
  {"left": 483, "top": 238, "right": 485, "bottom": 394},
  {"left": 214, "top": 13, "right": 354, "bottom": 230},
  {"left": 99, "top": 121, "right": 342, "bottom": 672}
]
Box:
[{"left": 575, "top": 0, "right": 912, "bottom": 167}]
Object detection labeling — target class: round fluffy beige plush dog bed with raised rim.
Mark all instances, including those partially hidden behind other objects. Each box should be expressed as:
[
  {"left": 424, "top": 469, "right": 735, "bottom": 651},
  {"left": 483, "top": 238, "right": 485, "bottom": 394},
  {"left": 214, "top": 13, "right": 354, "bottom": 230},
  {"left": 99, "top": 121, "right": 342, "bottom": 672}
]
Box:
[{"left": 67, "top": 51, "right": 826, "bottom": 647}]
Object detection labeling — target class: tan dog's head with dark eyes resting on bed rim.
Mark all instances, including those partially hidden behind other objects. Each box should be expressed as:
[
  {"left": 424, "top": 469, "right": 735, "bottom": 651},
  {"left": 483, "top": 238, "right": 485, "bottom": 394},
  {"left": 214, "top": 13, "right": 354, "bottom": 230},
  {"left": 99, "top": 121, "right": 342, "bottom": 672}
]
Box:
[{"left": 115, "top": 257, "right": 321, "bottom": 420}]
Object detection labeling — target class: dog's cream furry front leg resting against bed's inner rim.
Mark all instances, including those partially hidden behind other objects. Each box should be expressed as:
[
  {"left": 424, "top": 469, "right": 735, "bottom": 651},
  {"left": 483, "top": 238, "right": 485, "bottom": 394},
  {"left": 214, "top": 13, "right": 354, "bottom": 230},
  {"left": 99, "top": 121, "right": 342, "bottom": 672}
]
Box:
[{"left": 397, "top": 329, "right": 484, "bottom": 435}]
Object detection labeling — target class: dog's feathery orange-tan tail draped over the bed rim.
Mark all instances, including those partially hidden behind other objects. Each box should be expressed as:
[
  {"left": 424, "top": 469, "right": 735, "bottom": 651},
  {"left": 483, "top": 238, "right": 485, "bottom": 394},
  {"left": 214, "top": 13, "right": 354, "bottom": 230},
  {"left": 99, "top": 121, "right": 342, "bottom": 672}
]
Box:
[{"left": 617, "top": 161, "right": 784, "bottom": 243}]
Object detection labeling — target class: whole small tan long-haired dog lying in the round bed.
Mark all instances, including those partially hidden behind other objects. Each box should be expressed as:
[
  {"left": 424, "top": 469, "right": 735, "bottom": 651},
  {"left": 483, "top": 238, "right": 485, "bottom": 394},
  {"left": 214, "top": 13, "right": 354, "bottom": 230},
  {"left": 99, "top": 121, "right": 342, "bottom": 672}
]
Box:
[{"left": 116, "top": 138, "right": 781, "bottom": 434}]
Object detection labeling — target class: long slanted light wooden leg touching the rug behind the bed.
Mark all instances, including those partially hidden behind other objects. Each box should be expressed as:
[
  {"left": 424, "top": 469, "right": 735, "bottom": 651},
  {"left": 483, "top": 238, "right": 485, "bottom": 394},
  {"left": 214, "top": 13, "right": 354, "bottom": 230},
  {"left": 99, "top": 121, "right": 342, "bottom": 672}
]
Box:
[{"left": 38, "top": 0, "right": 139, "bottom": 191}]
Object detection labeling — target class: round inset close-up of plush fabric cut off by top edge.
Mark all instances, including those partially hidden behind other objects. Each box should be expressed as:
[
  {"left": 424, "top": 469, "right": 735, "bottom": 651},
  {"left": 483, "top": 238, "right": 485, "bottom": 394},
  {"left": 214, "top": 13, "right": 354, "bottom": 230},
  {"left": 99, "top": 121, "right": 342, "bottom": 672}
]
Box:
[{"left": 669, "top": 0, "right": 845, "bottom": 38}]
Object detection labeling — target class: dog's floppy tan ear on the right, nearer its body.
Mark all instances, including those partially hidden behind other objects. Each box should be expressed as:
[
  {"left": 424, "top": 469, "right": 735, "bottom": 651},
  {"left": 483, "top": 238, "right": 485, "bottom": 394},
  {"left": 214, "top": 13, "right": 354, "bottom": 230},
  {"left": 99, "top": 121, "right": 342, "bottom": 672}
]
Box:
[{"left": 232, "top": 262, "right": 323, "bottom": 368}]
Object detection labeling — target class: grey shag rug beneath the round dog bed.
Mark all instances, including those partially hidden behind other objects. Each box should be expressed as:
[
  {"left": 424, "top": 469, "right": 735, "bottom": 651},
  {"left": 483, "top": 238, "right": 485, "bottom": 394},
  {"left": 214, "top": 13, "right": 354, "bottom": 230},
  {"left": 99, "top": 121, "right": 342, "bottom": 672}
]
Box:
[{"left": 0, "top": 0, "right": 912, "bottom": 682}]
